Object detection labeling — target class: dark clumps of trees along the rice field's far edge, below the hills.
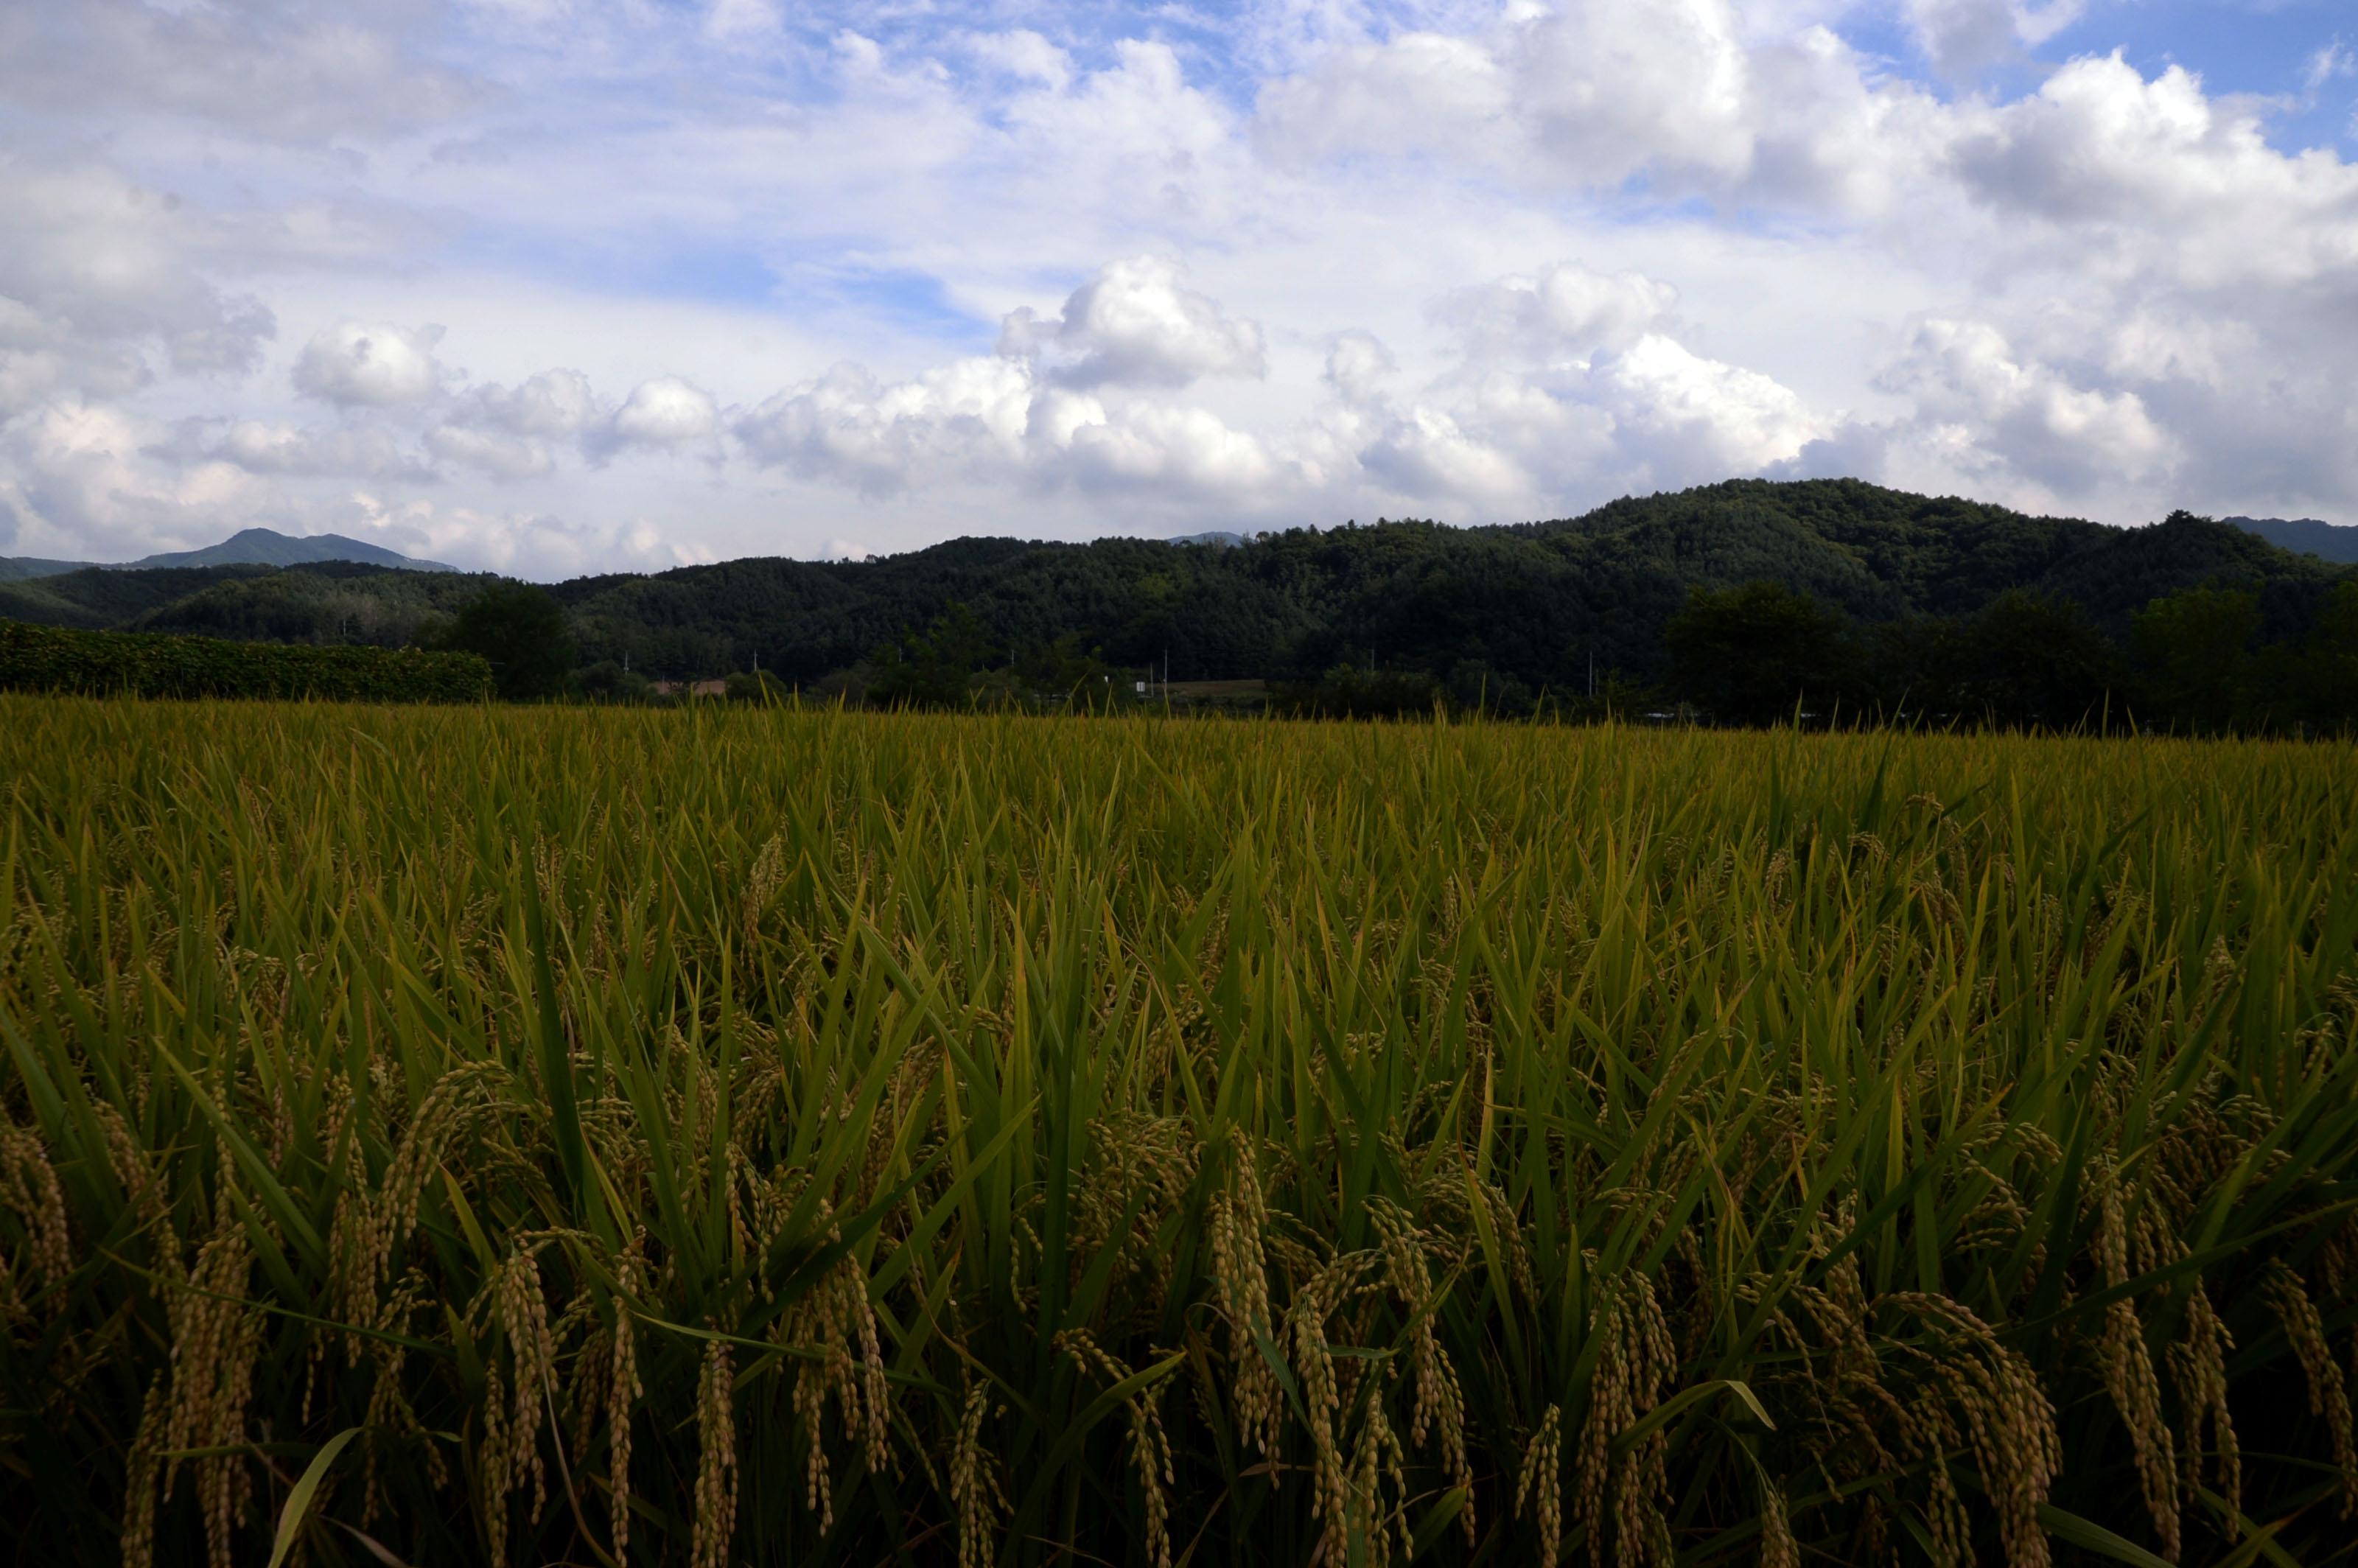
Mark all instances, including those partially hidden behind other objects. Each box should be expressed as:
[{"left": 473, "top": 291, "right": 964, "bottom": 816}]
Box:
[{"left": 410, "top": 568, "right": 2358, "bottom": 733}]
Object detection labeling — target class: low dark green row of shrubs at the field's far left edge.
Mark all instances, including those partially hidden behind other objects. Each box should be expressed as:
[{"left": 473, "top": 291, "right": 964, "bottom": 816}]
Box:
[{"left": 0, "top": 620, "right": 491, "bottom": 703}]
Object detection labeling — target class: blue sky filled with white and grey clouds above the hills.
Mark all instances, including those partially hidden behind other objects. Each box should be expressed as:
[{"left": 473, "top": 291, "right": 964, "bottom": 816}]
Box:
[{"left": 0, "top": 0, "right": 2358, "bottom": 575}]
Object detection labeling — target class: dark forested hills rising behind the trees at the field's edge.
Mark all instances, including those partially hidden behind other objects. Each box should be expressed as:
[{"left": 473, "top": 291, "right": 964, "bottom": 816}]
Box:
[{"left": 0, "top": 481, "right": 2351, "bottom": 691}]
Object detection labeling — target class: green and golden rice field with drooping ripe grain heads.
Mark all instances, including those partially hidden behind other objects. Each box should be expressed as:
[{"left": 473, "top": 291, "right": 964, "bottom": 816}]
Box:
[{"left": 0, "top": 698, "right": 2358, "bottom": 1568}]
